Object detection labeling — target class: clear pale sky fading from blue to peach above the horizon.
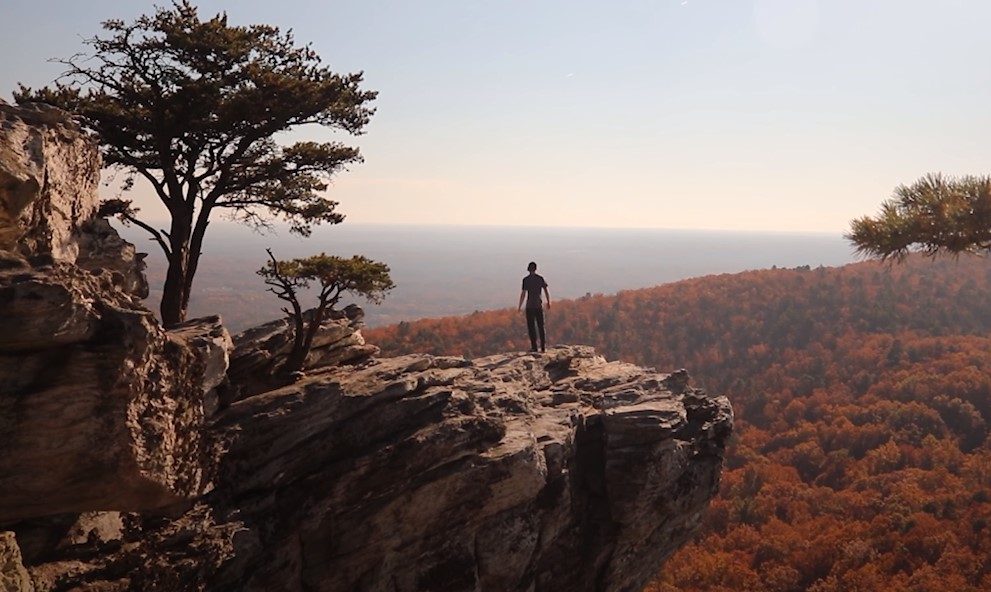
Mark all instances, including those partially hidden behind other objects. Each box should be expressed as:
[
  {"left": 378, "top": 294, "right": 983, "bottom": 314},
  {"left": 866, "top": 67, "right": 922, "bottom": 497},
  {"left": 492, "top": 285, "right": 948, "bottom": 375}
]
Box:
[{"left": 0, "top": 0, "right": 991, "bottom": 233}]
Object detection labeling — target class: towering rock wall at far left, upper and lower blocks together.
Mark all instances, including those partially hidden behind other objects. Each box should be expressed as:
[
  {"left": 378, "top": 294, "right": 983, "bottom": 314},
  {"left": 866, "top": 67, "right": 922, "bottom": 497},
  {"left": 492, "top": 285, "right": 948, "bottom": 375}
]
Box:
[{"left": 0, "top": 105, "right": 223, "bottom": 523}]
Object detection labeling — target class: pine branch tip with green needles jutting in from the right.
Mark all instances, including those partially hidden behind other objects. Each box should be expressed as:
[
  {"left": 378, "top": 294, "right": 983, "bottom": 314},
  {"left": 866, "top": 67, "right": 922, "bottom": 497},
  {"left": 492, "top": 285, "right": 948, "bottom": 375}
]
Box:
[{"left": 846, "top": 174, "right": 991, "bottom": 259}]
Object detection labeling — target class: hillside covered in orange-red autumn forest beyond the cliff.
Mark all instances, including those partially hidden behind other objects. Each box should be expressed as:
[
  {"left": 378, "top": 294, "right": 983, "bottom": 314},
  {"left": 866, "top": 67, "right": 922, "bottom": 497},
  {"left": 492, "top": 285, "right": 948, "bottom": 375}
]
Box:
[{"left": 365, "top": 257, "right": 991, "bottom": 592}]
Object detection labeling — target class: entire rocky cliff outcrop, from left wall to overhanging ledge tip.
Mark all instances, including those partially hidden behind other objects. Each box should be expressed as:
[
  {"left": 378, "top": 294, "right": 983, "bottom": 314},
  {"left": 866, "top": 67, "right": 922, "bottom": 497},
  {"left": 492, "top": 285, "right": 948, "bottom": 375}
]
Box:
[{"left": 0, "top": 99, "right": 732, "bottom": 592}]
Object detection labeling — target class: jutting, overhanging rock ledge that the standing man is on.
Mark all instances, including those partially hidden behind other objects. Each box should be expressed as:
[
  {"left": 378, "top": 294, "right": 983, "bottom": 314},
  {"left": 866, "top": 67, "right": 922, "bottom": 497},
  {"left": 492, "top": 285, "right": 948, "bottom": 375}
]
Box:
[{"left": 213, "top": 346, "right": 732, "bottom": 592}]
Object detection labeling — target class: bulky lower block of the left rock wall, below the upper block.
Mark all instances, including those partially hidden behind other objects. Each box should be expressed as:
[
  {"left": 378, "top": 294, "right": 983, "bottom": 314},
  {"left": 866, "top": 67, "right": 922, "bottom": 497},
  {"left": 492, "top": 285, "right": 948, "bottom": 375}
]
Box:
[{"left": 0, "top": 268, "right": 217, "bottom": 523}]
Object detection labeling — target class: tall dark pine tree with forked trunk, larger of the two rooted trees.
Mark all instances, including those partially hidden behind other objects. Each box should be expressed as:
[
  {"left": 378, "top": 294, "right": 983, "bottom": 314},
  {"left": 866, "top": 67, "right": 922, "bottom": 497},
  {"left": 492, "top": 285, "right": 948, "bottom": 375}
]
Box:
[{"left": 14, "top": 0, "right": 376, "bottom": 325}]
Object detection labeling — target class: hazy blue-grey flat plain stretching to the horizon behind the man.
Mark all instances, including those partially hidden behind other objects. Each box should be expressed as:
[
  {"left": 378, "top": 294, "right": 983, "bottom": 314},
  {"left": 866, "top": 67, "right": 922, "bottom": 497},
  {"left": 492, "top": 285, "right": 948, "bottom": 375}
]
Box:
[{"left": 119, "top": 222, "right": 858, "bottom": 332}]
